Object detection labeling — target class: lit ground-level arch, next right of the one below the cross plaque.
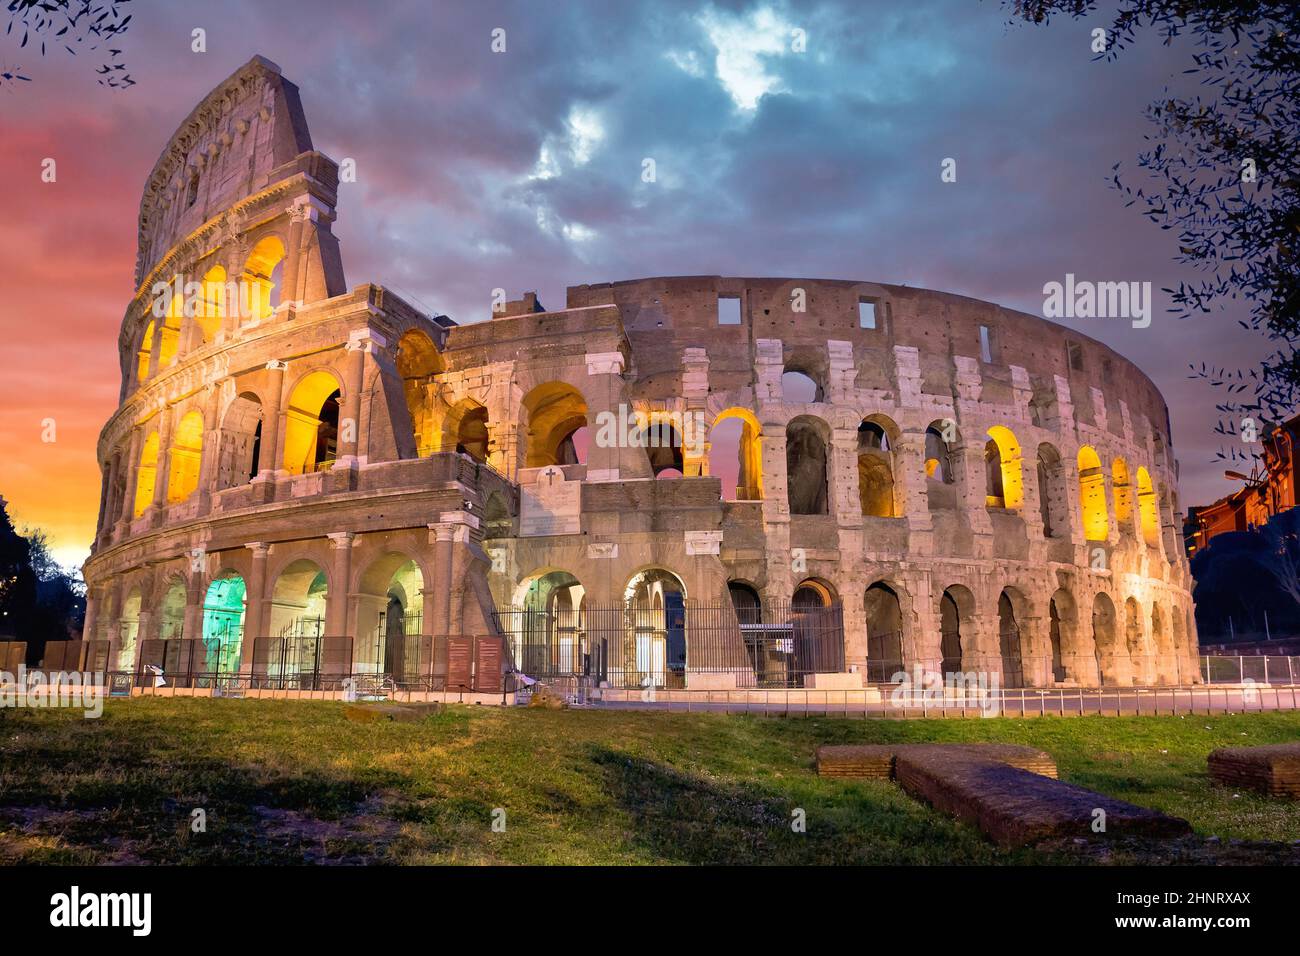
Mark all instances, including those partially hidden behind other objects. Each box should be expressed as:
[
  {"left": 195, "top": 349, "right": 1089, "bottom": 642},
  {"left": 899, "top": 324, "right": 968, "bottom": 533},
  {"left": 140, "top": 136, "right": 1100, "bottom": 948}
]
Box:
[{"left": 623, "top": 567, "right": 688, "bottom": 687}]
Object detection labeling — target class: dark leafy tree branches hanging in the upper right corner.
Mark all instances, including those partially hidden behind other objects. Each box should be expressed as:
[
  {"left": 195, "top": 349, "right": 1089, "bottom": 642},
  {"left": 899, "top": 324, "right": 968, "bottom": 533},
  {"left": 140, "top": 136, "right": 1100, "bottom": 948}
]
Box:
[{"left": 1004, "top": 0, "right": 1300, "bottom": 460}]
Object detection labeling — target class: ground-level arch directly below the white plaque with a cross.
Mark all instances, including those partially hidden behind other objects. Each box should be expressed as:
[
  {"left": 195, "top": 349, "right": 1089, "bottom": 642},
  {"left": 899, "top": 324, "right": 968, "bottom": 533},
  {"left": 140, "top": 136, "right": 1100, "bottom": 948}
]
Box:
[{"left": 502, "top": 571, "right": 590, "bottom": 678}]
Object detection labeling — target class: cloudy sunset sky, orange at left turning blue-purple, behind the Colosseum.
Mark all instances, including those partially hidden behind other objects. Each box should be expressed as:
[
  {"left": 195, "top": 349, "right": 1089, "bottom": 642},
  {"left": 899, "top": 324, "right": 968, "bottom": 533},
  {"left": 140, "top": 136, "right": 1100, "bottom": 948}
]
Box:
[{"left": 0, "top": 0, "right": 1258, "bottom": 563}]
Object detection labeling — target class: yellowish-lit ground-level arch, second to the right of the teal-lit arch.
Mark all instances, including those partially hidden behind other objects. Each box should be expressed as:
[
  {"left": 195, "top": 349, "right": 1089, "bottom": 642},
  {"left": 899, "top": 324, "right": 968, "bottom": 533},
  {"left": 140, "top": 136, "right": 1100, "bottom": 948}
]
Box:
[{"left": 352, "top": 551, "right": 433, "bottom": 683}]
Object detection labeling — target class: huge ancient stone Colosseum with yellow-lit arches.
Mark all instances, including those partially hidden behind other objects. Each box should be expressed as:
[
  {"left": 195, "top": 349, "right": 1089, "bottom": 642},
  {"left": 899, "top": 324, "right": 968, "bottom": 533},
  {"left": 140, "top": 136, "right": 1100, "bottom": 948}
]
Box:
[{"left": 85, "top": 57, "right": 1199, "bottom": 691}]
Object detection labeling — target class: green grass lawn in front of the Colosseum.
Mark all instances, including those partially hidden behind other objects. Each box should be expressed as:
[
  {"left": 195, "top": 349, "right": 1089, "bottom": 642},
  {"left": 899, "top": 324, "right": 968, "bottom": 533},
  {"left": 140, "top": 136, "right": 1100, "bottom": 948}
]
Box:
[{"left": 0, "top": 698, "right": 1300, "bottom": 864}]
